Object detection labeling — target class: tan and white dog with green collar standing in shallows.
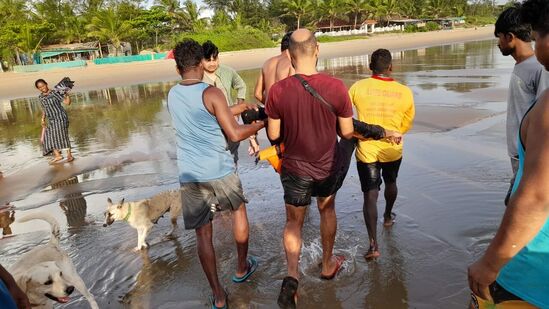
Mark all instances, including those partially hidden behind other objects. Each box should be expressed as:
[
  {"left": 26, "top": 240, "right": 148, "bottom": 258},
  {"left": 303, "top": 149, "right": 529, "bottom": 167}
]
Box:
[{"left": 103, "top": 190, "right": 181, "bottom": 250}]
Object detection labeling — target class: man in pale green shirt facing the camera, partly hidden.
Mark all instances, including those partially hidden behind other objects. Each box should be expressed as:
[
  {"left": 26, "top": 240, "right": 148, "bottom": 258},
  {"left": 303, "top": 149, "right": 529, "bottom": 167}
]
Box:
[{"left": 202, "top": 41, "right": 259, "bottom": 159}]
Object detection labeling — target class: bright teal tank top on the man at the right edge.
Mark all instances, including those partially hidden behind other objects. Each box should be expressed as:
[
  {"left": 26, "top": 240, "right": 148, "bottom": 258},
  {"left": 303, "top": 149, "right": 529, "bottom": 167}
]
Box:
[{"left": 497, "top": 103, "right": 549, "bottom": 308}]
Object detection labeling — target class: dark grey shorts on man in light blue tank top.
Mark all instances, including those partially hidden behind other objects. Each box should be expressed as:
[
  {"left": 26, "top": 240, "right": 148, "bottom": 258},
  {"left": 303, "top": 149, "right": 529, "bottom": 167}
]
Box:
[{"left": 180, "top": 173, "right": 248, "bottom": 230}]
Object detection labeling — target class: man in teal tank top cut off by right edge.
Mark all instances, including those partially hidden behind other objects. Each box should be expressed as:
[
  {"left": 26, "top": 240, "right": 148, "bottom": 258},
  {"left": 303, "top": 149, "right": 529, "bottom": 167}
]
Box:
[{"left": 469, "top": 0, "right": 549, "bottom": 308}]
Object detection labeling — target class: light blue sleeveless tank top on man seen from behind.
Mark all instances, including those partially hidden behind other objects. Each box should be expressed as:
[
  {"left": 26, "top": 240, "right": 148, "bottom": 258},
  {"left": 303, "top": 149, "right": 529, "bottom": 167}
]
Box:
[{"left": 168, "top": 83, "right": 235, "bottom": 183}]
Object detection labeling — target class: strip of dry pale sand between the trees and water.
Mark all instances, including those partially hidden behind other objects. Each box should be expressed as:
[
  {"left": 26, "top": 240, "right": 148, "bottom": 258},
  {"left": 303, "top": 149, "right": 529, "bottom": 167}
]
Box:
[{"left": 0, "top": 26, "right": 494, "bottom": 100}]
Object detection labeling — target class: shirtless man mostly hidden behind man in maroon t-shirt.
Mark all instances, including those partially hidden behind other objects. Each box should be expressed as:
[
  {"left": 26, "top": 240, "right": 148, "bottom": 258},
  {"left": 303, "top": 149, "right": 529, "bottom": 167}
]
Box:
[{"left": 254, "top": 31, "right": 295, "bottom": 103}]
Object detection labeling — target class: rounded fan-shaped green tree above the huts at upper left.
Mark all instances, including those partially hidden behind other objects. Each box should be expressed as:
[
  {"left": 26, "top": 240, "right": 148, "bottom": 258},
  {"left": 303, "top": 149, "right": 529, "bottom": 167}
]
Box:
[{"left": 86, "top": 8, "right": 132, "bottom": 56}]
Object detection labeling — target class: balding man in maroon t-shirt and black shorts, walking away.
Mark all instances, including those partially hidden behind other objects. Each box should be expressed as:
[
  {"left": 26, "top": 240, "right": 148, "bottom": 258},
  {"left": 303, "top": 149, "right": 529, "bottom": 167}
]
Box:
[{"left": 265, "top": 29, "right": 353, "bottom": 308}]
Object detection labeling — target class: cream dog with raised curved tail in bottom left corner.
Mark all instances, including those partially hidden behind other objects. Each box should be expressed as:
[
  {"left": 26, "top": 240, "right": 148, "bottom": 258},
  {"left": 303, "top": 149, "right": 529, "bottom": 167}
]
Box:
[{"left": 10, "top": 213, "right": 99, "bottom": 309}]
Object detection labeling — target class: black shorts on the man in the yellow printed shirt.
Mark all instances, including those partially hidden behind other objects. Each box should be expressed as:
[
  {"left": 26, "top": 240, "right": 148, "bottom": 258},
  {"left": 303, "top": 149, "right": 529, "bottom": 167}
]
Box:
[{"left": 357, "top": 158, "right": 402, "bottom": 192}]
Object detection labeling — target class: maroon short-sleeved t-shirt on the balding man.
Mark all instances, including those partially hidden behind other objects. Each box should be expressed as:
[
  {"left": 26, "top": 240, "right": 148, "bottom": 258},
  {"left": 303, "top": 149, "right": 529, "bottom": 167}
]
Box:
[{"left": 265, "top": 73, "right": 353, "bottom": 180}]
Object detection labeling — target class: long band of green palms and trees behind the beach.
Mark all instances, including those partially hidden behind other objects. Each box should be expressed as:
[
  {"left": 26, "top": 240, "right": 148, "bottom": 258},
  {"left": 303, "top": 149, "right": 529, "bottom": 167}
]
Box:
[{"left": 0, "top": 0, "right": 506, "bottom": 64}]
